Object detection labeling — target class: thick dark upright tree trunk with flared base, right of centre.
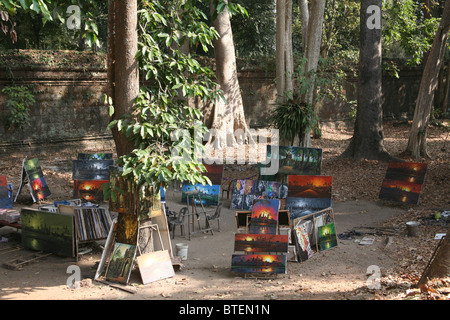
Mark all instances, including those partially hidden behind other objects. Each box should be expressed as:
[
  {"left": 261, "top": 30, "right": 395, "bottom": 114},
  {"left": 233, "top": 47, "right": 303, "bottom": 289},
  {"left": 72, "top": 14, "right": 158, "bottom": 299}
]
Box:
[{"left": 342, "top": 0, "right": 391, "bottom": 161}]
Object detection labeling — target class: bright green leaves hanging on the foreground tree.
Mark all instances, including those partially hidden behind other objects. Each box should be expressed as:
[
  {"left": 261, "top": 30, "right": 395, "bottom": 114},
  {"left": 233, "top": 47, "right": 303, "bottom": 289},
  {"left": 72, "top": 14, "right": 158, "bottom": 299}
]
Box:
[{"left": 109, "top": 0, "right": 221, "bottom": 189}]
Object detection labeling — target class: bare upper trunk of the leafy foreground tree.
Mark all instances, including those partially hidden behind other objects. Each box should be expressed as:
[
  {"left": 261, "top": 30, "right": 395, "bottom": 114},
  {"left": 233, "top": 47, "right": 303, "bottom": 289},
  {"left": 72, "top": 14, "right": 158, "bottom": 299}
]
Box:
[{"left": 110, "top": 0, "right": 139, "bottom": 156}]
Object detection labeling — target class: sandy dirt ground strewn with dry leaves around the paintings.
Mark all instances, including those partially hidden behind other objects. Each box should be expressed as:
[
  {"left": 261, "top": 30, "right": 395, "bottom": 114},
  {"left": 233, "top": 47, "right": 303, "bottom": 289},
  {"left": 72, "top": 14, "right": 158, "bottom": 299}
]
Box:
[{"left": 0, "top": 122, "right": 450, "bottom": 301}]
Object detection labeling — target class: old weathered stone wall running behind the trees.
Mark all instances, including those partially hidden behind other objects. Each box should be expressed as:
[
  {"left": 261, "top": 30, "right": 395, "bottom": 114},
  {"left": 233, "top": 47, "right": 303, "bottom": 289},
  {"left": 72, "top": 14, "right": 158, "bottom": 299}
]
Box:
[{"left": 0, "top": 61, "right": 436, "bottom": 151}]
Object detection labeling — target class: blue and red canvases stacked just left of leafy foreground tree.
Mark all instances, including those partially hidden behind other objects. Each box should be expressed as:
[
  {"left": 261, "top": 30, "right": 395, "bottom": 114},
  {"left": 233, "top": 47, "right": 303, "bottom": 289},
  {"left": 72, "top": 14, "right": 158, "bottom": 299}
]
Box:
[{"left": 73, "top": 153, "right": 114, "bottom": 202}]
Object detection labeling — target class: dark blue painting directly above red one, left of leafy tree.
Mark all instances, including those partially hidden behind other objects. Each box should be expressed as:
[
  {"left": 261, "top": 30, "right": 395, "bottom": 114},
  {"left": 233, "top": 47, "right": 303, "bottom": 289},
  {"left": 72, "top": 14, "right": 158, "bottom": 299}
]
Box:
[{"left": 72, "top": 160, "right": 114, "bottom": 180}]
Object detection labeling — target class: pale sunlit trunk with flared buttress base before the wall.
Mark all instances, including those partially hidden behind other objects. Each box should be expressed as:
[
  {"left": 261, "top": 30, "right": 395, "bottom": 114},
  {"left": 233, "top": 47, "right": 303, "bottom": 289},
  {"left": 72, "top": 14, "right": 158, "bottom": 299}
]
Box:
[{"left": 209, "top": 0, "right": 253, "bottom": 149}]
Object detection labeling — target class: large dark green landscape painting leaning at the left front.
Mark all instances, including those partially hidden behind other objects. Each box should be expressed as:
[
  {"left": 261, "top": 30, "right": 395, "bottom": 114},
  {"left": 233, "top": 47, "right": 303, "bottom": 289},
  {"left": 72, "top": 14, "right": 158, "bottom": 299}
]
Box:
[{"left": 20, "top": 208, "right": 76, "bottom": 257}]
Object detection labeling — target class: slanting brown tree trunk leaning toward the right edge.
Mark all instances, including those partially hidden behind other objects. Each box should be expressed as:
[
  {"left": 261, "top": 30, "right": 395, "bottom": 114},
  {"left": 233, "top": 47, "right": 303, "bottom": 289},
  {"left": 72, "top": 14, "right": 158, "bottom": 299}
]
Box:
[{"left": 405, "top": 1, "right": 450, "bottom": 160}]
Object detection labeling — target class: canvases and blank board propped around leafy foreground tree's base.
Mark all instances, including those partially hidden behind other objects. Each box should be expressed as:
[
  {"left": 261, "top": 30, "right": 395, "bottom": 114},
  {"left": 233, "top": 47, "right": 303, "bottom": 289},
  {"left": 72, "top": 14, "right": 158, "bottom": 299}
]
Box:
[{"left": 94, "top": 176, "right": 174, "bottom": 284}]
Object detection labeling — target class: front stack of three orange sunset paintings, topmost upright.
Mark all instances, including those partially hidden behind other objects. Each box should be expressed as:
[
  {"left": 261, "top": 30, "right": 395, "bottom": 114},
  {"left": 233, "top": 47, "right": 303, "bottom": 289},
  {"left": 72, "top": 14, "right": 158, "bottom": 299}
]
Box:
[{"left": 231, "top": 199, "right": 289, "bottom": 274}]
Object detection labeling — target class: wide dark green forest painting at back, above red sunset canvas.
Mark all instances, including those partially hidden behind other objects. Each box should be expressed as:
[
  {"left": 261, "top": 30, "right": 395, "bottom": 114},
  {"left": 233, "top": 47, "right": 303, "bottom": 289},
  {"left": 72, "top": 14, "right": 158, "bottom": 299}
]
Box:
[{"left": 260, "top": 145, "right": 322, "bottom": 180}]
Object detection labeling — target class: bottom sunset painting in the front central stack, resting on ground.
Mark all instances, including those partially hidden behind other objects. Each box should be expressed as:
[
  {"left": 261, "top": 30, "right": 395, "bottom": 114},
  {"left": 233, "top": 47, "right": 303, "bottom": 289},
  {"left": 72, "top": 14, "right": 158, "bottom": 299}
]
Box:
[{"left": 231, "top": 254, "right": 287, "bottom": 274}]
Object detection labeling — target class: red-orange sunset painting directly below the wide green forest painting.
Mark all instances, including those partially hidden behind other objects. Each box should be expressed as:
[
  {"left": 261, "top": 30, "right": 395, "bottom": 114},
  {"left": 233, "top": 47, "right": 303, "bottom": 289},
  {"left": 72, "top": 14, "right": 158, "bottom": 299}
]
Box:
[{"left": 288, "top": 175, "right": 333, "bottom": 198}]
